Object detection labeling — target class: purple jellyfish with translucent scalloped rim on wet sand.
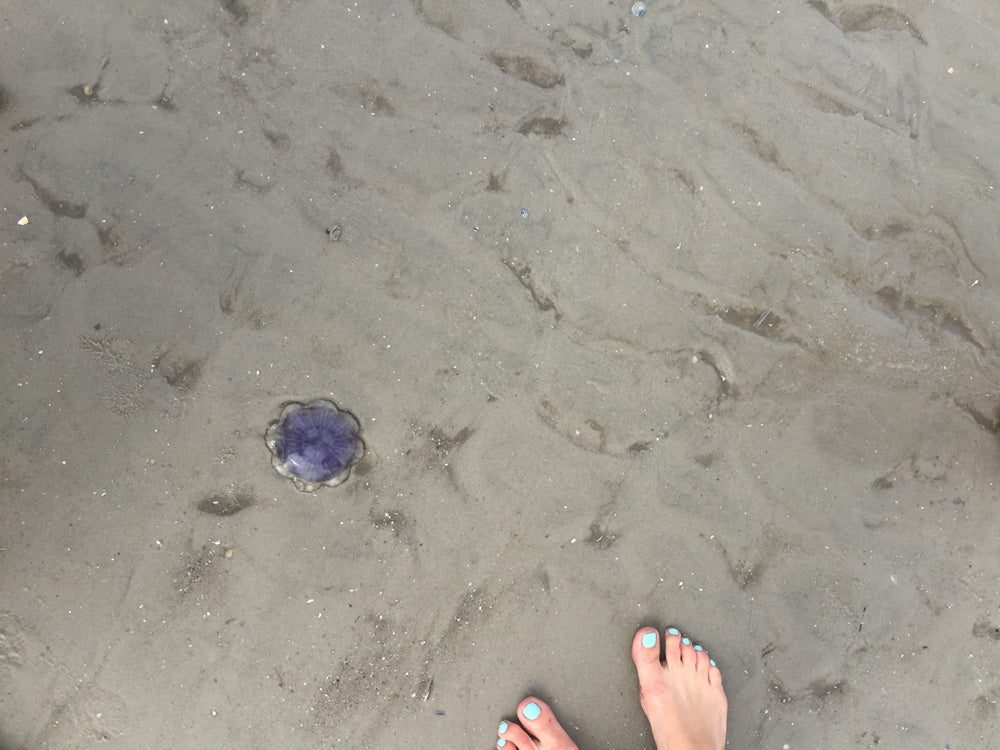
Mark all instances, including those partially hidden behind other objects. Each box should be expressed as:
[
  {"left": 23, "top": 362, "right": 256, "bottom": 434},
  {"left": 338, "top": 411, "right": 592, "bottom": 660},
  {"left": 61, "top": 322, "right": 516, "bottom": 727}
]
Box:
[{"left": 264, "top": 398, "right": 365, "bottom": 492}]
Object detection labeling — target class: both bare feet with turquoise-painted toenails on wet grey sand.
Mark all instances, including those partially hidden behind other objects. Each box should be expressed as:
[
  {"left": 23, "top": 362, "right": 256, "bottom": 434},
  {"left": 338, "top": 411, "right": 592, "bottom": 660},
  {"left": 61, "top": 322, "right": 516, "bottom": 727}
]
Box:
[{"left": 497, "top": 628, "right": 727, "bottom": 750}]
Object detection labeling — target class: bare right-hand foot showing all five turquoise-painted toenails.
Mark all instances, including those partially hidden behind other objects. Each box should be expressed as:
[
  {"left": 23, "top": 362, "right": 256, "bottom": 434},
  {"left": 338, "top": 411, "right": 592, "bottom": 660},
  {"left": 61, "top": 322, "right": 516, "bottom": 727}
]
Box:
[{"left": 632, "top": 628, "right": 728, "bottom": 750}]
